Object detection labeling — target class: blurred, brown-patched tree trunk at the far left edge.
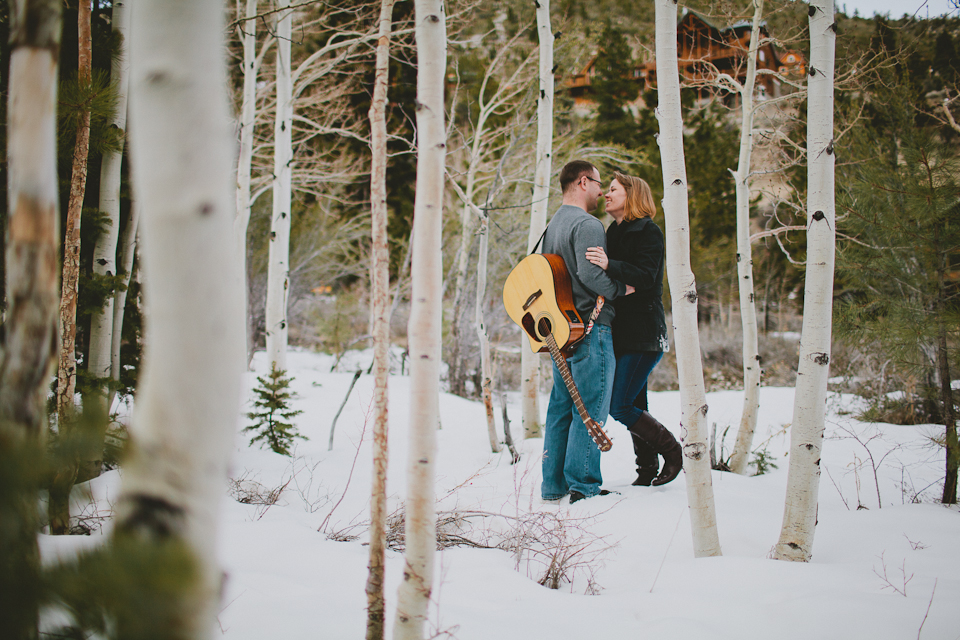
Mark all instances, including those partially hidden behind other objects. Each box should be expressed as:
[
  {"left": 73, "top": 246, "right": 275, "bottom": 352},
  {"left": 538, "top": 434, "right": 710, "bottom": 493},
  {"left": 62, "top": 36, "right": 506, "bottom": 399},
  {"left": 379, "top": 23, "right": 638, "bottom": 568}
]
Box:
[{"left": 0, "top": 0, "right": 61, "bottom": 440}]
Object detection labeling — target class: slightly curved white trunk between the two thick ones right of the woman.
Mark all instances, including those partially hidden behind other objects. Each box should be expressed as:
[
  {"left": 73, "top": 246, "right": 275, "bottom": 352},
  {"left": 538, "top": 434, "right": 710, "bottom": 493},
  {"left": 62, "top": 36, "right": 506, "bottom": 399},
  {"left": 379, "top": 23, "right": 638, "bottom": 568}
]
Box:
[{"left": 730, "top": 0, "right": 763, "bottom": 474}]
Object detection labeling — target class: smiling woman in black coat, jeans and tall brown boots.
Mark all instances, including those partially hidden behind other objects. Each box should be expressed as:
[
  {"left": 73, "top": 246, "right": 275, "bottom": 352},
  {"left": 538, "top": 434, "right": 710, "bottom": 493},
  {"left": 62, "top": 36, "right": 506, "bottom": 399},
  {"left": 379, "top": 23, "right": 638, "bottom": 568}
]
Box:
[{"left": 587, "top": 172, "right": 683, "bottom": 486}]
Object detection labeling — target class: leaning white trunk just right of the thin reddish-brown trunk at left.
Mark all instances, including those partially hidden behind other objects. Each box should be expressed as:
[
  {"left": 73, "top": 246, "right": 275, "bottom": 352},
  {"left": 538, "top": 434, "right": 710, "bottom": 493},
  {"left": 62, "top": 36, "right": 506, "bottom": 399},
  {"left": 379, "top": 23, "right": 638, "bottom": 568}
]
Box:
[{"left": 87, "top": 2, "right": 130, "bottom": 412}]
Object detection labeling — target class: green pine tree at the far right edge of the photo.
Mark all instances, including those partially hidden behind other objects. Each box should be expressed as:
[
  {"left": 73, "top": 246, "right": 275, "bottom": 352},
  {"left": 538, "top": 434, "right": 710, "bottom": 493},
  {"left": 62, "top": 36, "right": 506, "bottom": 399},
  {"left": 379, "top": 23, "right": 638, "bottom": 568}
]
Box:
[{"left": 835, "top": 82, "right": 960, "bottom": 503}]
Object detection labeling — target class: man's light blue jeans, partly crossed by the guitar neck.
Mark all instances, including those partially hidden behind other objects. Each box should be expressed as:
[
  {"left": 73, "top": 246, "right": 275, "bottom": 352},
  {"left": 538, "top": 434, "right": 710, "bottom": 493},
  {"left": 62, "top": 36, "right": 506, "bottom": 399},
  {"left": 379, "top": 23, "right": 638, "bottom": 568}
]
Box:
[{"left": 540, "top": 324, "right": 616, "bottom": 500}]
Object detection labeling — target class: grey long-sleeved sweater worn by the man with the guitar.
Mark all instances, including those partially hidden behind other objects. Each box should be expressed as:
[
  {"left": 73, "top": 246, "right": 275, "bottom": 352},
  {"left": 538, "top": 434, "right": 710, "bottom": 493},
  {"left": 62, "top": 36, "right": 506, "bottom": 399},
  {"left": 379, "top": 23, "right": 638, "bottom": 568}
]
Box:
[{"left": 543, "top": 204, "right": 627, "bottom": 325}]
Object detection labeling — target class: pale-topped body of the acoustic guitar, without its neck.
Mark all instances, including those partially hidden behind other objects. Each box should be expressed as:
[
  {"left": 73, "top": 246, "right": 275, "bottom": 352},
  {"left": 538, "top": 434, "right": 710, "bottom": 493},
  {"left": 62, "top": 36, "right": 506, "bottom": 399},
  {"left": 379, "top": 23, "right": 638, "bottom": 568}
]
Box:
[{"left": 503, "top": 253, "right": 584, "bottom": 356}]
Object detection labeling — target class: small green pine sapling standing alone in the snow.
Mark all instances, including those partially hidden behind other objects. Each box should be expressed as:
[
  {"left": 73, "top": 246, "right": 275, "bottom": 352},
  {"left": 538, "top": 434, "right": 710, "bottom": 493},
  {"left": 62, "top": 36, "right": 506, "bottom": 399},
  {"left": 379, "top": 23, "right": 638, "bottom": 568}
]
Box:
[{"left": 243, "top": 362, "right": 309, "bottom": 456}]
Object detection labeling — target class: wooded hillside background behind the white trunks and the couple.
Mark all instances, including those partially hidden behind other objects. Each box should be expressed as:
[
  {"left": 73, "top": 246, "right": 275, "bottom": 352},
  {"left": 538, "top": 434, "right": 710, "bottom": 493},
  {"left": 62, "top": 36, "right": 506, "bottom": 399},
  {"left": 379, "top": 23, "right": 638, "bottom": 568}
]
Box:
[{"left": 0, "top": 0, "right": 960, "bottom": 430}]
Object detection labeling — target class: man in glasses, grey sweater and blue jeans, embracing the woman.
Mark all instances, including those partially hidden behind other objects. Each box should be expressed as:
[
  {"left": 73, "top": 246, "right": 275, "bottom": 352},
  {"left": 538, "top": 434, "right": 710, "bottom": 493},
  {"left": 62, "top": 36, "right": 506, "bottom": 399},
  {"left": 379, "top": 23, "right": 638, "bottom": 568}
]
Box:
[{"left": 540, "top": 160, "right": 633, "bottom": 503}]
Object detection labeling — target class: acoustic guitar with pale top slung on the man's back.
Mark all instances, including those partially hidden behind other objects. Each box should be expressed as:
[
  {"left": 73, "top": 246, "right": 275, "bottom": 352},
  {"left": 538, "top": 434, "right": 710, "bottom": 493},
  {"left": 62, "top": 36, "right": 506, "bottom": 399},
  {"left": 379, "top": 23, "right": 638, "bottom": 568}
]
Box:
[{"left": 503, "top": 253, "right": 613, "bottom": 451}]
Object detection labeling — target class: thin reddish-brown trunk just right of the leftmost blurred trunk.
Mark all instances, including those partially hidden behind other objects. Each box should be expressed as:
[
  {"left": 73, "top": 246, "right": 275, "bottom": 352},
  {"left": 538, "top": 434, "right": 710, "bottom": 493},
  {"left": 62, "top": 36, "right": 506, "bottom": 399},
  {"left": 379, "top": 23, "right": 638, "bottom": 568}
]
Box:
[{"left": 48, "top": 0, "right": 93, "bottom": 535}]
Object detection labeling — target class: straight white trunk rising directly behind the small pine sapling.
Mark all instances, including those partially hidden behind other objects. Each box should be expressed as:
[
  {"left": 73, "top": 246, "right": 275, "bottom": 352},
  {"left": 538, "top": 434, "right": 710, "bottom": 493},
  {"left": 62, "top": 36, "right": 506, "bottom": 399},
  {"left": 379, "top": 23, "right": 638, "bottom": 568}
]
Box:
[{"left": 266, "top": 0, "right": 293, "bottom": 369}]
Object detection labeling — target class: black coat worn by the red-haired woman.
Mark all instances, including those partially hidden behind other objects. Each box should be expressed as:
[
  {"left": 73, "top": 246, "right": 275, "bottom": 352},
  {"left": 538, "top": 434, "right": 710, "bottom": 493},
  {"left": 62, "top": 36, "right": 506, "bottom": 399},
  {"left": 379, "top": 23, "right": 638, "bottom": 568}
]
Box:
[{"left": 607, "top": 218, "right": 670, "bottom": 355}]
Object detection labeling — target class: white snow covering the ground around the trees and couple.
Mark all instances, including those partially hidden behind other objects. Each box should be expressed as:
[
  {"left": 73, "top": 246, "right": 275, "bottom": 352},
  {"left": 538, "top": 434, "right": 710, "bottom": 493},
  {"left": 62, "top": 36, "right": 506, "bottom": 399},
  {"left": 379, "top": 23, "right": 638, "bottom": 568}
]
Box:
[{"left": 41, "top": 351, "right": 960, "bottom": 640}]
